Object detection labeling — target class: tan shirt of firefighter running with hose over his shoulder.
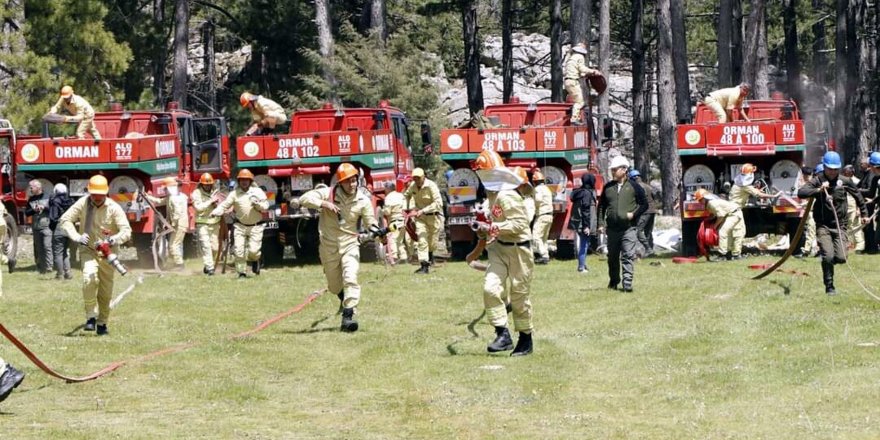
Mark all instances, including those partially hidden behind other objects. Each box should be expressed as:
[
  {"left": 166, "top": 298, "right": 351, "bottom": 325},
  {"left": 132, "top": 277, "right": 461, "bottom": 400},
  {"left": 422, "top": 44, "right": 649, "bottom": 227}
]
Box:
[{"left": 299, "top": 186, "right": 376, "bottom": 254}]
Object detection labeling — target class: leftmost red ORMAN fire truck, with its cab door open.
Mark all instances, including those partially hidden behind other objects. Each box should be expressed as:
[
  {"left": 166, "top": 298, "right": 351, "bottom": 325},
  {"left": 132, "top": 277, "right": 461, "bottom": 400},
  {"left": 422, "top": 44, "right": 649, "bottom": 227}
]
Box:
[{"left": 4, "top": 102, "right": 230, "bottom": 258}]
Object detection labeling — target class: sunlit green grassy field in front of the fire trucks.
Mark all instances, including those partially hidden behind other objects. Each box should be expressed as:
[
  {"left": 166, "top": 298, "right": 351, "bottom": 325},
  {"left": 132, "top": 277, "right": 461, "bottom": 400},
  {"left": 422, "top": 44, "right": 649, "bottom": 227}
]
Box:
[{"left": 0, "top": 251, "right": 880, "bottom": 439}]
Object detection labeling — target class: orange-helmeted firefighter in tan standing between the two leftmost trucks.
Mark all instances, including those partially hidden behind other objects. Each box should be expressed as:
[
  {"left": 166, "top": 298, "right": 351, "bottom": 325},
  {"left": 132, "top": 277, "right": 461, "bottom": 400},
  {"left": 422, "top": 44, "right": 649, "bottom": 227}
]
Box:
[{"left": 190, "top": 173, "right": 223, "bottom": 276}]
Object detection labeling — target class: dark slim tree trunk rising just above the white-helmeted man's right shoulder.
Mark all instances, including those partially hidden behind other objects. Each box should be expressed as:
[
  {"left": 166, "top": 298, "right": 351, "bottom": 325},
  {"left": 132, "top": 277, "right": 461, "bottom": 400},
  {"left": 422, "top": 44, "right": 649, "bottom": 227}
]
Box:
[{"left": 630, "top": 0, "right": 651, "bottom": 175}]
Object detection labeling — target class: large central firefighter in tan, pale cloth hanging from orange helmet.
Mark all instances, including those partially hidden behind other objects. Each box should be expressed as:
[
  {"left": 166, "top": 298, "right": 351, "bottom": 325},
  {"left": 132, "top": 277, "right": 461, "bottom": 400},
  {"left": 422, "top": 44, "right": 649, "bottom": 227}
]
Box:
[{"left": 472, "top": 150, "right": 534, "bottom": 356}]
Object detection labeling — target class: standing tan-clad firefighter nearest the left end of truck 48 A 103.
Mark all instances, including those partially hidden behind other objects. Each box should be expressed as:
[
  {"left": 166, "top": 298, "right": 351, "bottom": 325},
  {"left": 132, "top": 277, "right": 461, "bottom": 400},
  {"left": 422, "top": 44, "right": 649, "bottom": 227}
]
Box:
[{"left": 403, "top": 168, "right": 443, "bottom": 274}]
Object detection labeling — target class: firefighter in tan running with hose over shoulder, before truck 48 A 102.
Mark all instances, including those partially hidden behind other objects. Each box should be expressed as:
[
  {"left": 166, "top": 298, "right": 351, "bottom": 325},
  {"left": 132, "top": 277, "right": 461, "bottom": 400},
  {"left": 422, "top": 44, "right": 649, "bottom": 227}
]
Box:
[{"left": 300, "top": 163, "right": 377, "bottom": 332}]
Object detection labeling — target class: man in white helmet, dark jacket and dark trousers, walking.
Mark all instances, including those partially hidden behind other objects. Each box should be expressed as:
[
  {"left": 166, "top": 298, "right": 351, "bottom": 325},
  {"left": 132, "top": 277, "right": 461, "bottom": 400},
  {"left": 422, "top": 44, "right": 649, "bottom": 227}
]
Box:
[{"left": 598, "top": 156, "right": 648, "bottom": 292}]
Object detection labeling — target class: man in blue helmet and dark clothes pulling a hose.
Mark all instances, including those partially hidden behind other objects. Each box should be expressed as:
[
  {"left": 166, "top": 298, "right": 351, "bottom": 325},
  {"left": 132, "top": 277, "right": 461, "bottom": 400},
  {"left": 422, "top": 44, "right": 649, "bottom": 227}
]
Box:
[{"left": 798, "top": 151, "right": 868, "bottom": 295}]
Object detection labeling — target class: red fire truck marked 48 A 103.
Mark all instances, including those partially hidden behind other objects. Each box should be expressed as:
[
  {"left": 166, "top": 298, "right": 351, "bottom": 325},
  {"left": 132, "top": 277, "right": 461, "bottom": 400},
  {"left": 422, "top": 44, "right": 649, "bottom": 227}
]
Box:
[{"left": 440, "top": 98, "right": 603, "bottom": 259}]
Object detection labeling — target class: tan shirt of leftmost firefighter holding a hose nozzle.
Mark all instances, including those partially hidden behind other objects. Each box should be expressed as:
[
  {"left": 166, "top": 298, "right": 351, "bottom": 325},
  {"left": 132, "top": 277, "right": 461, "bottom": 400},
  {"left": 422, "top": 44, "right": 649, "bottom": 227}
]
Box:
[{"left": 58, "top": 195, "right": 131, "bottom": 249}]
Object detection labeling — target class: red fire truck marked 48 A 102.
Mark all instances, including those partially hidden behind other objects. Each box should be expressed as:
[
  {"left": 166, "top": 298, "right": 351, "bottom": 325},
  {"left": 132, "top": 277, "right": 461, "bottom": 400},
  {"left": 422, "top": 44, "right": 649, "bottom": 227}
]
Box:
[{"left": 236, "top": 100, "right": 413, "bottom": 264}]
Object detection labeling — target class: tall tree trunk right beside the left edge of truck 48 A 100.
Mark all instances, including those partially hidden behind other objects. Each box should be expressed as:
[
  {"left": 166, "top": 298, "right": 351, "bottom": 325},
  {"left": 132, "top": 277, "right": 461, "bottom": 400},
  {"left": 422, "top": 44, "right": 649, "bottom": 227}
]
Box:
[{"left": 655, "top": 0, "right": 681, "bottom": 215}]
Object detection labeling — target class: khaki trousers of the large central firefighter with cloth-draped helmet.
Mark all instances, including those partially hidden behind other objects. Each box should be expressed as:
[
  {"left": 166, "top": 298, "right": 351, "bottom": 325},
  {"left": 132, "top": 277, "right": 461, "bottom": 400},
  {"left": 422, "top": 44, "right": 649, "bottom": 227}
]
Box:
[{"left": 483, "top": 242, "right": 535, "bottom": 333}]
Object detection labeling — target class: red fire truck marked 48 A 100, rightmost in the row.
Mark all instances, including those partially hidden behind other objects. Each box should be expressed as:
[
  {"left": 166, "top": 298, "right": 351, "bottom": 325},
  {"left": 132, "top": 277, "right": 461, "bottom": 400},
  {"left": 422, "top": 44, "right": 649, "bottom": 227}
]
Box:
[{"left": 676, "top": 99, "right": 824, "bottom": 256}]
